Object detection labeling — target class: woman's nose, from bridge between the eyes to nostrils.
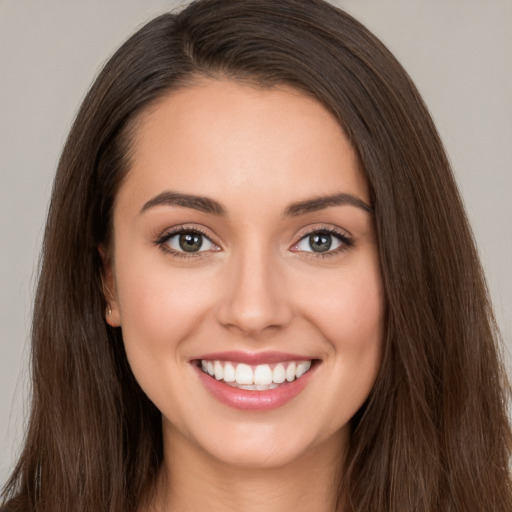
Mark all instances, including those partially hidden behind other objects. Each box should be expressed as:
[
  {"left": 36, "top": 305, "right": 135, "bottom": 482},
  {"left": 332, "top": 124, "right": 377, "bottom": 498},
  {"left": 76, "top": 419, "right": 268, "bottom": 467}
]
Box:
[{"left": 217, "top": 245, "right": 293, "bottom": 338}]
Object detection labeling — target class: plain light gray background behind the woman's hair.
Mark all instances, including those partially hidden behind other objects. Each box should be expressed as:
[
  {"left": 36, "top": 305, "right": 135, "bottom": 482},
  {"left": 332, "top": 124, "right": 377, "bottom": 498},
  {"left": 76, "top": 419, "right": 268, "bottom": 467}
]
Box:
[{"left": 0, "top": 0, "right": 512, "bottom": 483}]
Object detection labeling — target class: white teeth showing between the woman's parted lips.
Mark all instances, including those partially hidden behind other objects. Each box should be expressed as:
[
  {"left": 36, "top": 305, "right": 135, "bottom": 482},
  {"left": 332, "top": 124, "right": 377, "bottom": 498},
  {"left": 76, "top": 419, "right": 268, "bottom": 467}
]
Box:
[{"left": 197, "top": 359, "right": 317, "bottom": 391}]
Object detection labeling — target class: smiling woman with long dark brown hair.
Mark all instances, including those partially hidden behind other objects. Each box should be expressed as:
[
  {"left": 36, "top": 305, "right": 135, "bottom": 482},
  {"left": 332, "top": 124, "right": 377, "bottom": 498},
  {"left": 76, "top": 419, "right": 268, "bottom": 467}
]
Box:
[{"left": 4, "top": 0, "right": 512, "bottom": 512}]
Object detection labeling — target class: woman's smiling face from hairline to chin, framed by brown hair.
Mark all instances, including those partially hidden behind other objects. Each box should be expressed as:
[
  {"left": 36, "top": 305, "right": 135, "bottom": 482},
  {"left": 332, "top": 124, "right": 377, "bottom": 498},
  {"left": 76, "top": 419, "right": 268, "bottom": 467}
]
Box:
[{"left": 107, "top": 80, "right": 384, "bottom": 467}]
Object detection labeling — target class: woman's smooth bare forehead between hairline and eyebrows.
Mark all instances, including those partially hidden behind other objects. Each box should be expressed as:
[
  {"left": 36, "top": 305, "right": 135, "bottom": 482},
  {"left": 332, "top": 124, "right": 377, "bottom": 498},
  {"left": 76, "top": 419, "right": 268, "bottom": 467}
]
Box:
[{"left": 118, "top": 80, "right": 368, "bottom": 216}]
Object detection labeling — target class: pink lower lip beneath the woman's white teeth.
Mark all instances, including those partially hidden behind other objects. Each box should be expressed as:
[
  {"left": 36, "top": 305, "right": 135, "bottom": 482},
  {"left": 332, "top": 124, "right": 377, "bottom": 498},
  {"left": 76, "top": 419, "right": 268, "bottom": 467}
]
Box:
[{"left": 196, "top": 365, "right": 317, "bottom": 411}]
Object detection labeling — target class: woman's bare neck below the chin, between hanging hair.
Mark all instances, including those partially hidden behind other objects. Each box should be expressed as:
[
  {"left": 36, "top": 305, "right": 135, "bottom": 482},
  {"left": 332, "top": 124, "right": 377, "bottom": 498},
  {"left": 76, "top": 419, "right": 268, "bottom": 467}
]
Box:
[{"left": 150, "top": 424, "right": 347, "bottom": 512}]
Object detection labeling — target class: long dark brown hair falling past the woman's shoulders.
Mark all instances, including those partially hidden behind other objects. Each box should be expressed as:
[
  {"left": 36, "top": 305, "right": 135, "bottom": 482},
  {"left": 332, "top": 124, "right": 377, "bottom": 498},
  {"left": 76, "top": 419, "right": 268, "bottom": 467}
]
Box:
[{"left": 3, "top": 0, "right": 512, "bottom": 512}]
